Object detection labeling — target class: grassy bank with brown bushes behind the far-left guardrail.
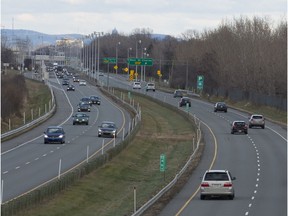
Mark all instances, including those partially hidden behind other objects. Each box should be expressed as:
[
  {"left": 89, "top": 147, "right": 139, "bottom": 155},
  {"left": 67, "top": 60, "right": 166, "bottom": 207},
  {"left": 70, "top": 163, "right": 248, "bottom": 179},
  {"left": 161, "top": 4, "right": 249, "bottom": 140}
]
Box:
[{"left": 1, "top": 70, "right": 51, "bottom": 133}]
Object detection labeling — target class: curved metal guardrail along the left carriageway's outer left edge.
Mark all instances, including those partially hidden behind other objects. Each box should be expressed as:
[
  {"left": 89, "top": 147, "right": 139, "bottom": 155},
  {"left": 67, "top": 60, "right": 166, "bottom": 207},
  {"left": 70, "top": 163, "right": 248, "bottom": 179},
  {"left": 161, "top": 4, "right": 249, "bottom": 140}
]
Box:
[{"left": 1, "top": 84, "right": 56, "bottom": 140}]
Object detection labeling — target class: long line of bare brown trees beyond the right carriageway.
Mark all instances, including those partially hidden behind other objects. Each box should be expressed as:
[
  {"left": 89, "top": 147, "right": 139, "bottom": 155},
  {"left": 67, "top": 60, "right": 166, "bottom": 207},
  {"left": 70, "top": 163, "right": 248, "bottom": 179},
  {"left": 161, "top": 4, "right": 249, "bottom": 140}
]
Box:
[{"left": 2, "top": 17, "right": 287, "bottom": 109}]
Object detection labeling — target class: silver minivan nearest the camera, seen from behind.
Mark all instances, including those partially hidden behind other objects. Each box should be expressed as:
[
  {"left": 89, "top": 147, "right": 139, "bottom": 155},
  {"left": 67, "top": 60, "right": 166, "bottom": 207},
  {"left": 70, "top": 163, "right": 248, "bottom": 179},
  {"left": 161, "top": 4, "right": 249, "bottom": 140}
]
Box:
[{"left": 200, "top": 170, "right": 236, "bottom": 200}]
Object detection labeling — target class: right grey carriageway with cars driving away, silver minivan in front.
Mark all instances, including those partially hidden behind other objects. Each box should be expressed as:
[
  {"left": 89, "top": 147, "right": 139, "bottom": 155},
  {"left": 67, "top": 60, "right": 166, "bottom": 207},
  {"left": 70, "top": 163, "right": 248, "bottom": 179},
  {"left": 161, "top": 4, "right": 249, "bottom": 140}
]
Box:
[{"left": 103, "top": 74, "right": 287, "bottom": 216}]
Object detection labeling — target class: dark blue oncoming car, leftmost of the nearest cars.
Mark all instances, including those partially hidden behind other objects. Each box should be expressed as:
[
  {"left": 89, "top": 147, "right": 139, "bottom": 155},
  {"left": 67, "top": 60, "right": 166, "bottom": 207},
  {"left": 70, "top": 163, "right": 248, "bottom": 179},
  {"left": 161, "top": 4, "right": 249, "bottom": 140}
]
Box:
[{"left": 44, "top": 126, "right": 65, "bottom": 144}]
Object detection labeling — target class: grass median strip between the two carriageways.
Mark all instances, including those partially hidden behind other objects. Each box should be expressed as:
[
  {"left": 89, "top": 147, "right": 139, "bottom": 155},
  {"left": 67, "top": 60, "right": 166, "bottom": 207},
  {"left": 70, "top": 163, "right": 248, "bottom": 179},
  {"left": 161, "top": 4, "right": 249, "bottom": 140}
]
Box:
[{"left": 17, "top": 90, "right": 195, "bottom": 216}]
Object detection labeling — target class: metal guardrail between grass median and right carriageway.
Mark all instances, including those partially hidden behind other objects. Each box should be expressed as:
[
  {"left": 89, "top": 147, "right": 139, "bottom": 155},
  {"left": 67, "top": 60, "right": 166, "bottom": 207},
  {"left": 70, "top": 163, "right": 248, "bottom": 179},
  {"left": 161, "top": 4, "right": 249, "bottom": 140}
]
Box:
[{"left": 132, "top": 112, "right": 201, "bottom": 216}]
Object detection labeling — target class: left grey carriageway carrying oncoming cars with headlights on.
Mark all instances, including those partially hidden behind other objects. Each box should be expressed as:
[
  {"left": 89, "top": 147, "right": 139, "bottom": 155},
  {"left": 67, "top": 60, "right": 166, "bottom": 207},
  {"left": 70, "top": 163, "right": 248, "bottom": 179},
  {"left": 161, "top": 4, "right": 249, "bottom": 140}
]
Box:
[{"left": 1, "top": 72, "right": 130, "bottom": 203}]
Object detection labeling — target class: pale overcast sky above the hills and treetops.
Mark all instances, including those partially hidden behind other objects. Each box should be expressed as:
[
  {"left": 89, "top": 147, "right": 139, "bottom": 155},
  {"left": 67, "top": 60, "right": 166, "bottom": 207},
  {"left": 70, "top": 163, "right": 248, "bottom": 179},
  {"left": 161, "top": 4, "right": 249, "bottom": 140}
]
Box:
[{"left": 1, "top": 0, "right": 287, "bottom": 36}]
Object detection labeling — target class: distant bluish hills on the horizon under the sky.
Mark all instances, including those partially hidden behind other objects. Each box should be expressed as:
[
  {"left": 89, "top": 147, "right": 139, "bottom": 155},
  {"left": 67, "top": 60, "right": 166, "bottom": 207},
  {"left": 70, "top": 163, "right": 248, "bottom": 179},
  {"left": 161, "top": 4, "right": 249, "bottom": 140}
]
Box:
[{"left": 1, "top": 29, "right": 167, "bottom": 48}]
